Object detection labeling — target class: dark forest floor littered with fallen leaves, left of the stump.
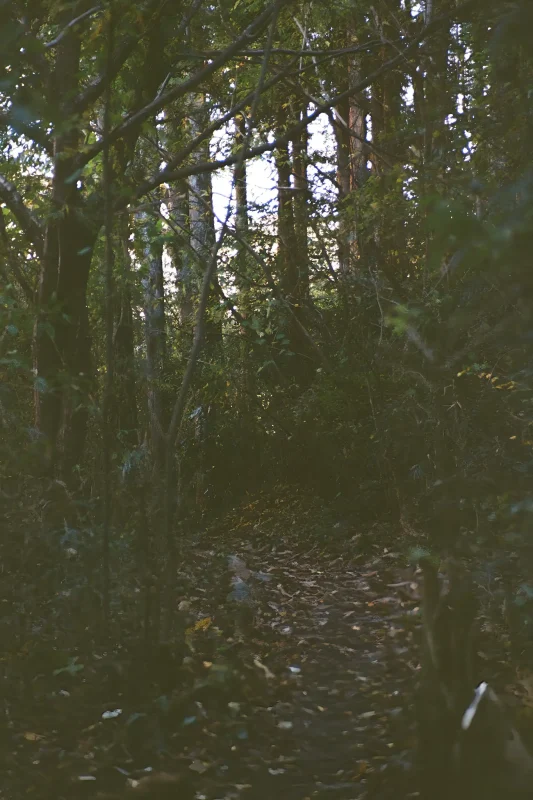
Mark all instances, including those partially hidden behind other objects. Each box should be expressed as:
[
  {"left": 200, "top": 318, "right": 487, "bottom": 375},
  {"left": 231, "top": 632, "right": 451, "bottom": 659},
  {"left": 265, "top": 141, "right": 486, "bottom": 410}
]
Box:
[{"left": 0, "top": 490, "right": 419, "bottom": 800}]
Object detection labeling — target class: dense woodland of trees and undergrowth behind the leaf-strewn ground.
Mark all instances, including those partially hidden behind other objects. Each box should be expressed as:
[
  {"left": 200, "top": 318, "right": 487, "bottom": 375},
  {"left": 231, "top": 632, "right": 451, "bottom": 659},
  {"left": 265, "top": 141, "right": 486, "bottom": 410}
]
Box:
[{"left": 0, "top": 0, "right": 533, "bottom": 796}]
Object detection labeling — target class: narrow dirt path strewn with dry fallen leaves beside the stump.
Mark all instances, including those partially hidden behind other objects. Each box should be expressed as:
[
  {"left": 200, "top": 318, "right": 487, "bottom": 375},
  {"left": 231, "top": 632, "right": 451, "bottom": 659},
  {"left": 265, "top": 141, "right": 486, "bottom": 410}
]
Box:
[{"left": 191, "top": 524, "right": 418, "bottom": 800}]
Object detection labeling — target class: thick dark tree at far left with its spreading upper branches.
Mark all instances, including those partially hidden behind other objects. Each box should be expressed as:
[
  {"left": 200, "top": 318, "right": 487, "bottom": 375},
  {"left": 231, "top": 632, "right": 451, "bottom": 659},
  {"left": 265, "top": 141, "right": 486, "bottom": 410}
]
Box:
[{"left": 0, "top": 0, "right": 283, "bottom": 477}]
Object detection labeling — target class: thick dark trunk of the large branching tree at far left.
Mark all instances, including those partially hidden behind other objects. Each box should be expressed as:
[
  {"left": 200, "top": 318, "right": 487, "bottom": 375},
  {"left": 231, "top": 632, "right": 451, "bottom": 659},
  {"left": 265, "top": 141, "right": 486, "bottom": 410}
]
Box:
[{"left": 33, "top": 12, "right": 97, "bottom": 482}]
